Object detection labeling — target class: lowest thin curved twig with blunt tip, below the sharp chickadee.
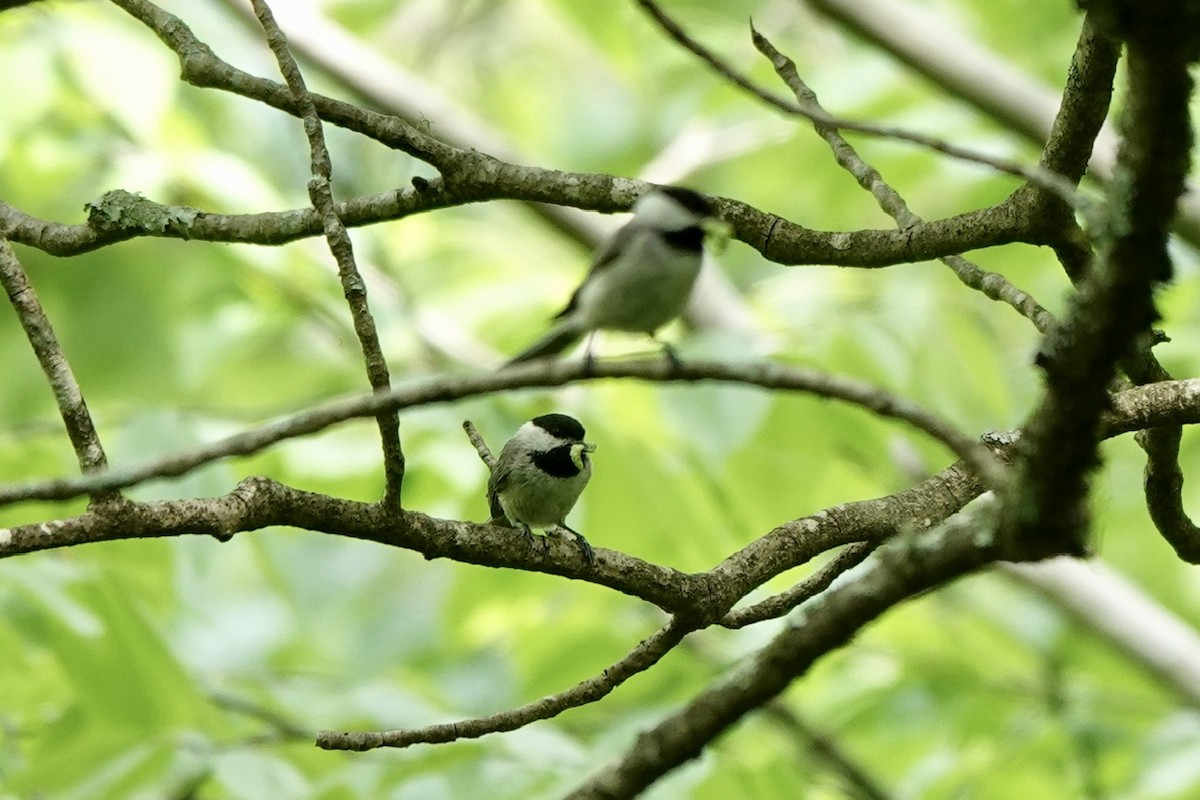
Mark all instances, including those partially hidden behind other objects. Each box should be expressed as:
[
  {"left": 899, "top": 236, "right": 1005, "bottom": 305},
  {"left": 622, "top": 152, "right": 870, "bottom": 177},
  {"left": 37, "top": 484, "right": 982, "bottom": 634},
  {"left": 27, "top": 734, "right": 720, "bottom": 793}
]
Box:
[{"left": 317, "top": 616, "right": 695, "bottom": 751}]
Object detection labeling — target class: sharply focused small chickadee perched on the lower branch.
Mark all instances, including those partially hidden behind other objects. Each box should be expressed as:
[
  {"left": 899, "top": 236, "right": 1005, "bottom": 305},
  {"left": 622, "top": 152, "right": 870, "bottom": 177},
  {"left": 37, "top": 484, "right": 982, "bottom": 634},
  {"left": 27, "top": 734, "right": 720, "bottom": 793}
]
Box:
[{"left": 487, "top": 414, "right": 595, "bottom": 564}]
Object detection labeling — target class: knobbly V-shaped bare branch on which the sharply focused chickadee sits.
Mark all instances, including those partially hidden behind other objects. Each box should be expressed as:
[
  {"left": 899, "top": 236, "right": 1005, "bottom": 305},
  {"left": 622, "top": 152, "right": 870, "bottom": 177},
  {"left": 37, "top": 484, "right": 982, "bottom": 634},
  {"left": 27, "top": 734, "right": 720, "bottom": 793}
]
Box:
[{"left": 0, "top": 448, "right": 1012, "bottom": 625}]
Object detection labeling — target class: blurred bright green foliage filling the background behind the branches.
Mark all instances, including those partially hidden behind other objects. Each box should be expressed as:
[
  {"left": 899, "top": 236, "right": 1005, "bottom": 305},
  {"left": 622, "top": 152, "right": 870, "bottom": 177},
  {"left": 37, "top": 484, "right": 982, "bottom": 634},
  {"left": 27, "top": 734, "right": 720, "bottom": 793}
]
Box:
[{"left": 0, "top": 0, "right": 1200, "bottom": 800}]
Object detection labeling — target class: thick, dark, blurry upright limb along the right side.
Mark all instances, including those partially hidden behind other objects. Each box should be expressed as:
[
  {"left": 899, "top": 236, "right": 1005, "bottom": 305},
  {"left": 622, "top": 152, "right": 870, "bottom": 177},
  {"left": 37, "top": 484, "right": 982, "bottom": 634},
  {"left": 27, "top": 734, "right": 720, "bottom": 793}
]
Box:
[{"left": 1003, "top": 8, "right": 1194, "bottom": 555}]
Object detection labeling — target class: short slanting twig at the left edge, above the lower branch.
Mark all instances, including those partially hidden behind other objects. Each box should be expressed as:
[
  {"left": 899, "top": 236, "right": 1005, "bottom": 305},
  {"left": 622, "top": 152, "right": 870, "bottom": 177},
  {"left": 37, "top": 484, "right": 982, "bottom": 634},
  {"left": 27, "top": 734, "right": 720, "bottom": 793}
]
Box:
[{"left": 0, "top": 237, "right": 116, "bottom": 501}]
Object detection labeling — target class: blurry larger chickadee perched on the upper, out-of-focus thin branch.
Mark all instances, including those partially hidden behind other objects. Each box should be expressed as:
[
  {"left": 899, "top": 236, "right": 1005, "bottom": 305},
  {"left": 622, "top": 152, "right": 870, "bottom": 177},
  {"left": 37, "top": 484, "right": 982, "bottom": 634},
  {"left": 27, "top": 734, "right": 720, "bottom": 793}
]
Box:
[{"left": 509, "top": 186, "right": 716, "bottom": 363}]
